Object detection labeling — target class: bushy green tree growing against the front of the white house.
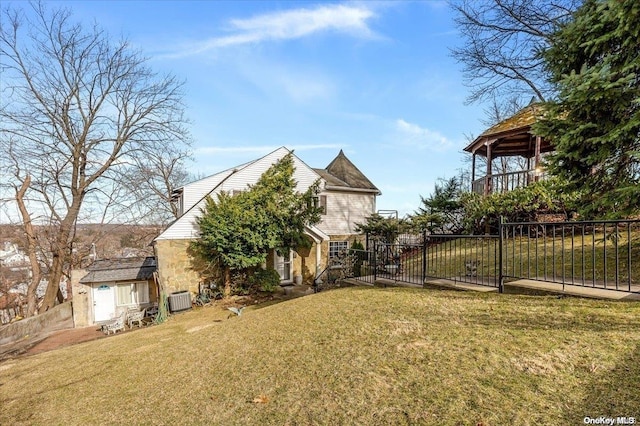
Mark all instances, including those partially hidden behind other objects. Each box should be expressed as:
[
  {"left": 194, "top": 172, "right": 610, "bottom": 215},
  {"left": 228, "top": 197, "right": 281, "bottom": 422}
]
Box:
[{"left": 191, "top": 154, "right": 320, "bottom": 297}]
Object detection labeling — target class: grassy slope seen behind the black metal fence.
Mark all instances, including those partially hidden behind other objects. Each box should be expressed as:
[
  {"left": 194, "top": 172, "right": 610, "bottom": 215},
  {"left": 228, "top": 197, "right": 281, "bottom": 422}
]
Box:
[{"left": 420, "top": 230, "right": 640, "bottom": 289}]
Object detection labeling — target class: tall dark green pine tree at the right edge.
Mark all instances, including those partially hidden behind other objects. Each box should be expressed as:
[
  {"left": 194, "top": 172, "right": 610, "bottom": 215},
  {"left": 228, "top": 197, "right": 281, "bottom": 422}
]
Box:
[{"left": 534, "top": 0, "right": 640, "bottom": 218}]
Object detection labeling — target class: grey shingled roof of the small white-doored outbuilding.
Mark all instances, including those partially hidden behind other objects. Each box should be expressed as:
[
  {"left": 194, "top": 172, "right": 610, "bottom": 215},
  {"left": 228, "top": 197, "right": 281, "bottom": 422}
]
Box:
[{"left": 80, "top": 256, "right": 156, "bottom": 284}]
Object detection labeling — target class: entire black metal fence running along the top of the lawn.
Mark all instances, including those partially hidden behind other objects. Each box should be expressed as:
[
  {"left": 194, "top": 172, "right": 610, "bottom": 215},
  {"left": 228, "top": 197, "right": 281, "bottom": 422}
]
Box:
[{"left": 342, "top": 220, "right": 640, "bottom": 293}]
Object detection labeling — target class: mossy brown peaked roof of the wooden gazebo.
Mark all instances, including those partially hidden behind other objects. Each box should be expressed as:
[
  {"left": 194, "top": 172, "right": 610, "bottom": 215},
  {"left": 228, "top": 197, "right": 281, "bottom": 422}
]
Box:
[{"left": 464, "top": 103, "right": 553, "bottom": 158}]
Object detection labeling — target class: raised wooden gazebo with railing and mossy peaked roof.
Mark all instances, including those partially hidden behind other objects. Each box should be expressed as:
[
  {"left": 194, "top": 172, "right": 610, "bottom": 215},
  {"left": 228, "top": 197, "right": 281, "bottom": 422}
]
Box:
[{"left": 464, "top": 103, "right": 553, "bottom": 195}]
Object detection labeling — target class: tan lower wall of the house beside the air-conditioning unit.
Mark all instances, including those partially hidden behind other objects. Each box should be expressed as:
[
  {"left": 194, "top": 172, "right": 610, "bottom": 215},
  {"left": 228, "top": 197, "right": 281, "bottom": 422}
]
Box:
[{"left": 155, "top": 240, "right": 201, "bottom": 294}]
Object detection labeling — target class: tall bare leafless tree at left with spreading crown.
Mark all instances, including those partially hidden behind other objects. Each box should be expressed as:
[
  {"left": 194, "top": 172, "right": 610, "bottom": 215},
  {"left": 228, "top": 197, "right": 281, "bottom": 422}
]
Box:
[{"left": 0, "top": 3, "right": 188, "bottom": 311}]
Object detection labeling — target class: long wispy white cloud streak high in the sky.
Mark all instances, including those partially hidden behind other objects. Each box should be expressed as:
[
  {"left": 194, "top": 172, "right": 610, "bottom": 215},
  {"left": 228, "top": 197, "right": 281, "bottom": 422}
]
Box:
[{"left": 162, "top": 4, "right": 377, "bottom": 58}]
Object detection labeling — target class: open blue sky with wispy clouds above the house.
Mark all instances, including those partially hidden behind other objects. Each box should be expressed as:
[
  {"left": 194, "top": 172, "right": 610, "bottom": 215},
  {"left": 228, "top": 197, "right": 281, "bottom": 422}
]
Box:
[{"left": 50, "top": 1, "right": 484, "bottom": 215}]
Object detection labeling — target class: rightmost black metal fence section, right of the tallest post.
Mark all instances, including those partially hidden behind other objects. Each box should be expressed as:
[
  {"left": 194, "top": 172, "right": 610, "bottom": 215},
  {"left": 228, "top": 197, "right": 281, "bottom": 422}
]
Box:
[{"left": 500, "top": 220, "right": 640, "bottom": 292}]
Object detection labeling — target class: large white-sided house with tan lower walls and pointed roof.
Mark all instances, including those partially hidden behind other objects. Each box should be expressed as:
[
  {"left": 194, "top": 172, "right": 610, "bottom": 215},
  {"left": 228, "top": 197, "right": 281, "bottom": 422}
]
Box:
[{"left": 153, "top": 147, "right": 380, "bottom": 293}]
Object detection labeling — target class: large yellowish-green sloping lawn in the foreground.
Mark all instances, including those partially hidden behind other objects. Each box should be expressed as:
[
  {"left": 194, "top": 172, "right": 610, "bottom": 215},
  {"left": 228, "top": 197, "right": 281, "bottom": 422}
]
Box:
[{"left": 0, "top": 287, "right": 640, "bottom": 426}]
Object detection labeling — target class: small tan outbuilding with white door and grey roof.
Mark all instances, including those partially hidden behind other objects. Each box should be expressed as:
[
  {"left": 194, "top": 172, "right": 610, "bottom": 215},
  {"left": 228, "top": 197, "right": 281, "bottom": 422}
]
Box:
[{"left": 71, "top": 257, "right": 158, "bottom": 327}]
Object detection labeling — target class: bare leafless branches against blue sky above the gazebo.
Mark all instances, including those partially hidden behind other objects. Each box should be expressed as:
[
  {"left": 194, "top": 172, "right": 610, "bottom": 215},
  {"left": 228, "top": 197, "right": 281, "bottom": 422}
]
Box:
[{"left": 450, "top": 0, "right": 582, "bottom": 102}]
